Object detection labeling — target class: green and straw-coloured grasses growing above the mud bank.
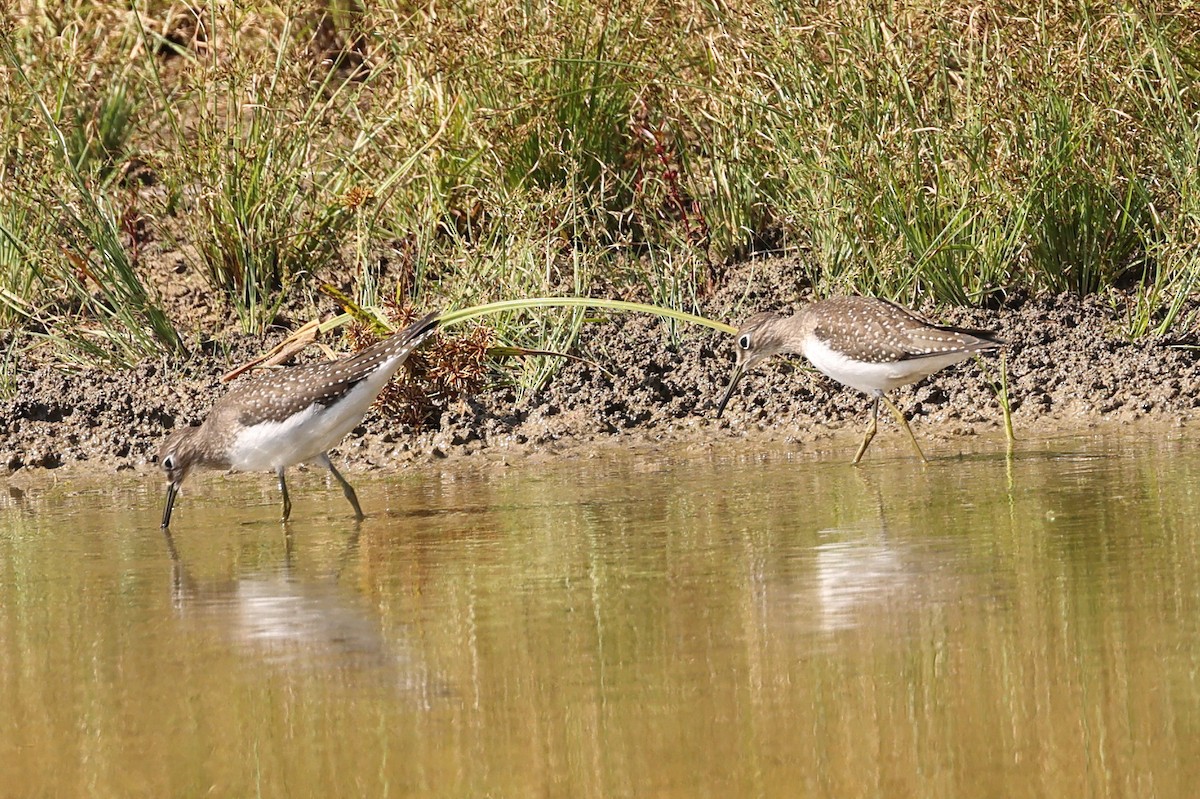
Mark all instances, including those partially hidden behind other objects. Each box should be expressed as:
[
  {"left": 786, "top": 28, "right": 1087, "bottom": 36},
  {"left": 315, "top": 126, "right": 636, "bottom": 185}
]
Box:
[{"left": 0, "top": 0, "right": 1200, "bottom": 379}]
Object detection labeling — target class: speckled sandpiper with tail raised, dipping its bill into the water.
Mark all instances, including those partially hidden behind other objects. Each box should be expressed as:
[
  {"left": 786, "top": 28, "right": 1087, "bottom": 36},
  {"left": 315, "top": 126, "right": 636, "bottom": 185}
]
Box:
[{"left": 158, "top": 313, "right": 438, "bottom": 528}]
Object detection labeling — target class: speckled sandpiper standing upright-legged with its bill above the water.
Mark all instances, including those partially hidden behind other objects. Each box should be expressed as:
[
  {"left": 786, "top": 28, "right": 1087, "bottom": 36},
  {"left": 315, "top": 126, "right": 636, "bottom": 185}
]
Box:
[{"left": 716, "top": 296, "right": 1004, "bottom": 463}]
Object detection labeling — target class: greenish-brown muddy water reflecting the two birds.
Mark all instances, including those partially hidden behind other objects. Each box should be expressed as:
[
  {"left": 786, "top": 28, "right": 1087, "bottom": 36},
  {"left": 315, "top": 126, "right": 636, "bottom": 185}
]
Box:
[{"left": 0, "top": 431, "right": 1200, "bottom": 798}]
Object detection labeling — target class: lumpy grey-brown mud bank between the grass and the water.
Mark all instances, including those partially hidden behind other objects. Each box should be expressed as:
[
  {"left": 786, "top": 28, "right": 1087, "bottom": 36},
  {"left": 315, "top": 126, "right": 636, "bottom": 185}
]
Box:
[{"left": 0, "top": 277, "right": 1200, "bottom": 473}]
